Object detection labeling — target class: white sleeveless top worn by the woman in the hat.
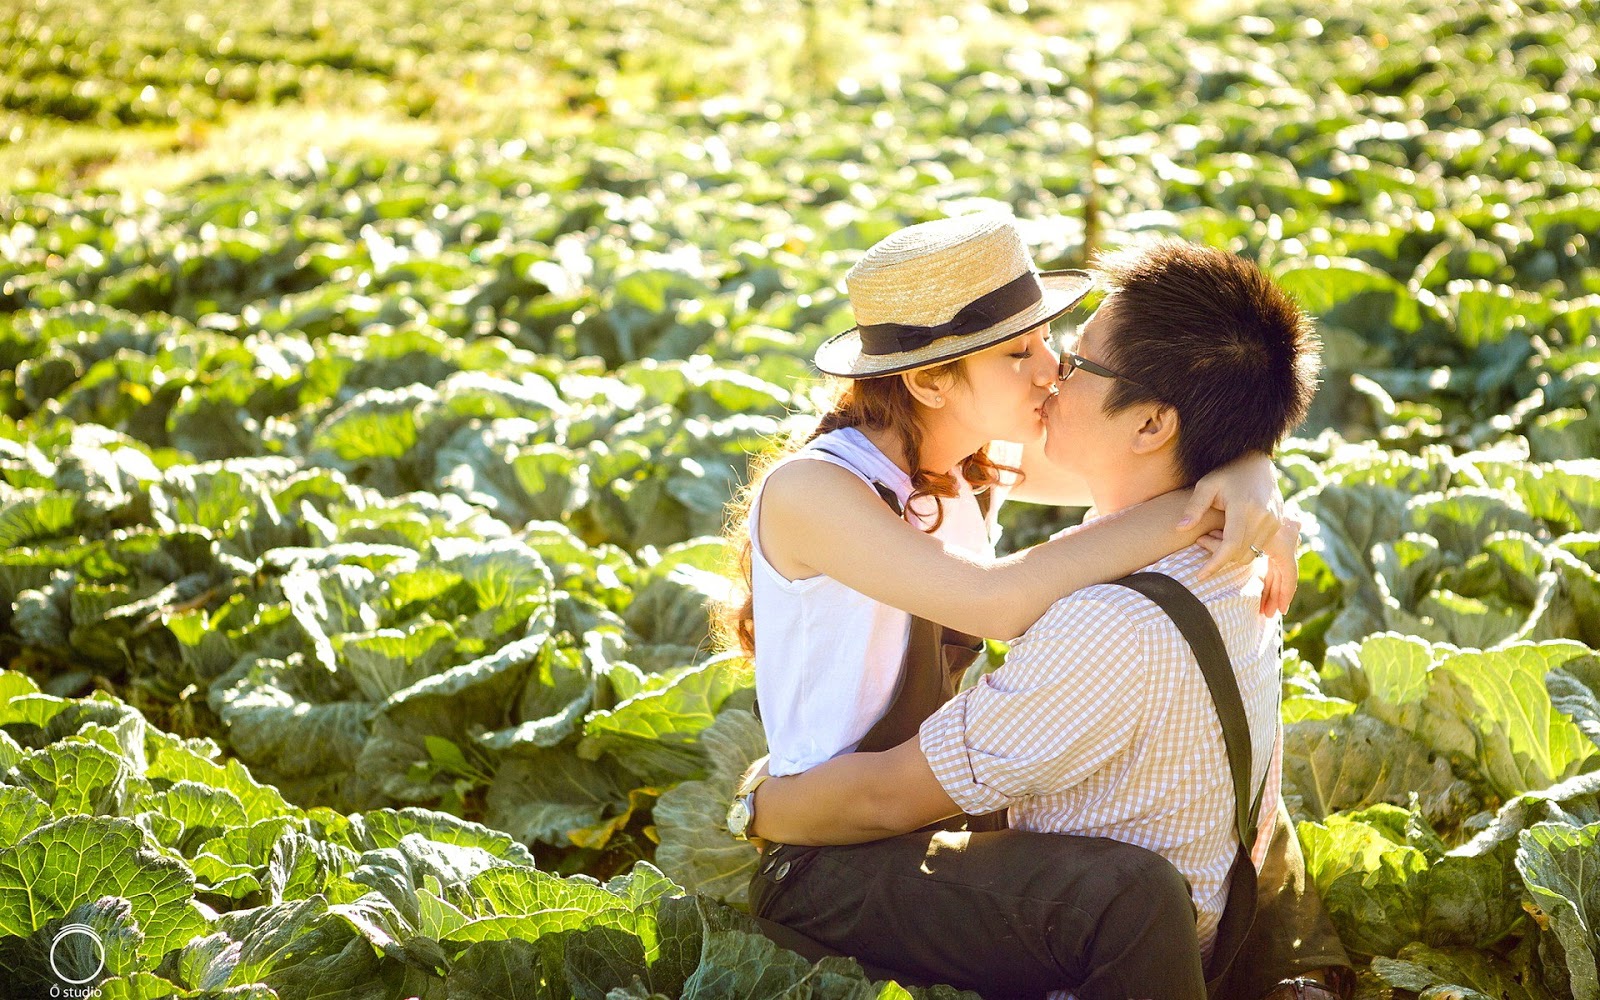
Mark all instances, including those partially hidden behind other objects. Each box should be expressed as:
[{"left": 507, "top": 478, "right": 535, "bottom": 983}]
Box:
[{"left": 749, "top": 427, "right": 1014, "bottom": 774}]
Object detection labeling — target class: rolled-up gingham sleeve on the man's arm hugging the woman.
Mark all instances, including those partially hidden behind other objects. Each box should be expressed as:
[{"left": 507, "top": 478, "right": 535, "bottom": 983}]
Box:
[{"left": 920, "top": 589, "right": 1147, "bottom": 814}]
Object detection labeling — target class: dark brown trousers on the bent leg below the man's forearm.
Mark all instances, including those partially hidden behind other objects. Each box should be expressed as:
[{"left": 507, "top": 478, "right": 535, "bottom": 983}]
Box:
[{"left": 750, "top": 830, "right": 1206, "bottom": 1000}]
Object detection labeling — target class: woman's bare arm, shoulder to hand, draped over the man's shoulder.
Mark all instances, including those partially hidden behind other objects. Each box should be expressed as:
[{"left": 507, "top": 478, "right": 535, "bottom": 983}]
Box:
[{"left": 757, "top": 462, "right": 1222, "bottom": 638}]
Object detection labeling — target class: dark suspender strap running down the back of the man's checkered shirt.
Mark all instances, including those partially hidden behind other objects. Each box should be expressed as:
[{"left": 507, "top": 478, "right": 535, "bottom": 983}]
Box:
[{"left": 1112, "top": 573, "right": 1266, "bottom": 854}]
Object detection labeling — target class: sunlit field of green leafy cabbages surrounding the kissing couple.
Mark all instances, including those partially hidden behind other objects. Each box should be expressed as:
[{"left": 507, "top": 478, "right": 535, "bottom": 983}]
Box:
[{"left": 0, "top": 0, "right": 1600, "bottom": 1000}]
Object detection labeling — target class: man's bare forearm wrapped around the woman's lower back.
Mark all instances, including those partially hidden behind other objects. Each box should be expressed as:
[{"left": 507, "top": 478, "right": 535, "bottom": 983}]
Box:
[{"left": 752, "top": 738, "right": 962, "bottom": 846}]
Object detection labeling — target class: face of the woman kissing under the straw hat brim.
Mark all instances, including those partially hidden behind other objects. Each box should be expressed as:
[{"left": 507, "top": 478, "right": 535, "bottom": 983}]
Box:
[{"left": 946, "top": 323, "right": 1058, "bottom": 445}]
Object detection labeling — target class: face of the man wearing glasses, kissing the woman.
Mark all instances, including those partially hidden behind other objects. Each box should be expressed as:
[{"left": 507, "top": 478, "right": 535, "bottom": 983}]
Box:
[{"left": 1043, "top": 294, "right": 1138, "bottom": 483}]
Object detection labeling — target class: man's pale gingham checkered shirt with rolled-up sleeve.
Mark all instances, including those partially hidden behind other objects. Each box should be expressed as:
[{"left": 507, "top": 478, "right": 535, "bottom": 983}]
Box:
[{"left": 922, "top": 547, "right": 1282, "bottom": 955}]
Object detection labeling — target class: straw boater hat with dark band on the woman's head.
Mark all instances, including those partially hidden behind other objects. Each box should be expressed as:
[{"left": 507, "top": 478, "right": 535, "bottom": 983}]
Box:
[{"left": 816, "top": 214, "right": 1094, "bottom": 379}]
